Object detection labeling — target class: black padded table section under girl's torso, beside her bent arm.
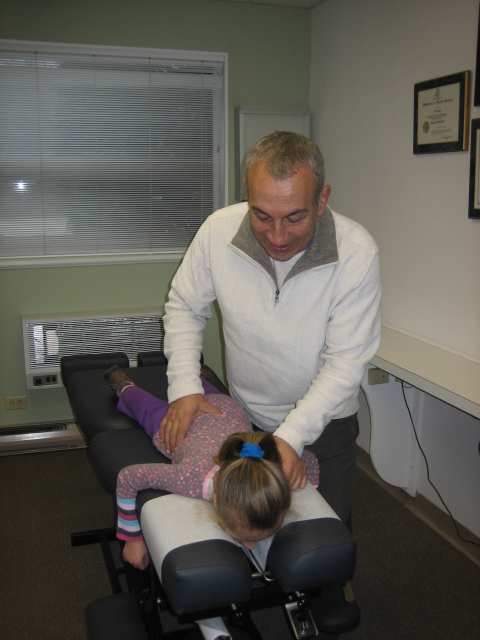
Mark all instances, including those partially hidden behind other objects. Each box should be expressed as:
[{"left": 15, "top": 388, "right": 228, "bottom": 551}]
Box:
[{"left": 89, "top": 428, "right": 170, "bottom": 496}]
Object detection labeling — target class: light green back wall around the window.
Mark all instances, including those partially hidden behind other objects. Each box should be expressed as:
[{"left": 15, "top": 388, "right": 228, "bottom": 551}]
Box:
[{"left": 0, "top": 0, "right": 310, "bottom": 425}]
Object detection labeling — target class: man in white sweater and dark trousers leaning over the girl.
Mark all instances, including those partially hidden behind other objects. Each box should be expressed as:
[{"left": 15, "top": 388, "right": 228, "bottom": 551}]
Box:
[{"left": 161, "top": 132, "right": 380, "bottom": 526}]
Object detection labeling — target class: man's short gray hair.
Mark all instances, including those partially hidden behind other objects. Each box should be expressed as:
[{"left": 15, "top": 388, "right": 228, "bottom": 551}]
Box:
[{"left": 245, "top": 131, "right": 325, "bottom": 204}]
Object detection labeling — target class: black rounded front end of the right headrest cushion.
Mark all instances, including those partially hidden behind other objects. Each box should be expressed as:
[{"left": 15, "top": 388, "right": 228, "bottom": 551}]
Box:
[{"left": 267, "top": 518, "right": 357, "bottom": 593}]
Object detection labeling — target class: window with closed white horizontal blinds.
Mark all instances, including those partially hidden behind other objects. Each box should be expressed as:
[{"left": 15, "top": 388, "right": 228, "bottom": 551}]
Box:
[{"left": 0, "top": 41, "right": 226, "bottom": 266}]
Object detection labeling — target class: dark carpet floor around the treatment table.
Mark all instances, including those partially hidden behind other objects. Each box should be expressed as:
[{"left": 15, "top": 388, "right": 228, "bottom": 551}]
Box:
[{"left": 0, "top": 450, "right": 480, "bottom": 640}]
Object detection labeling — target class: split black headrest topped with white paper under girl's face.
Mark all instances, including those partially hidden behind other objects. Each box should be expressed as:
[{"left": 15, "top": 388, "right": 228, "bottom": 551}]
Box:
[{"left": 141, "top": 484, "right": 356, "bottom": 615}]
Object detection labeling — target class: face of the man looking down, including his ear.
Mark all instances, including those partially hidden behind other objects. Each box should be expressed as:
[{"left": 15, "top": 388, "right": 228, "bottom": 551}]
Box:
[{"left": 248, "top": 162, "right": 330, "bottom": 262}]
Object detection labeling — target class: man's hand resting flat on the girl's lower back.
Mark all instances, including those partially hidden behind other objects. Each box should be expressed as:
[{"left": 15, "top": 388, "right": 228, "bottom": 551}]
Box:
[{"left": 159, "top": 393, "right": 223, "bottom": 454}]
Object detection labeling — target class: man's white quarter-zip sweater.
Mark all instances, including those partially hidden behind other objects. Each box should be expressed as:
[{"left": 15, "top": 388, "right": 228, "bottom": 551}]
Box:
[{"left": 164, "top": 203, "right": 380, "bottom": 455}]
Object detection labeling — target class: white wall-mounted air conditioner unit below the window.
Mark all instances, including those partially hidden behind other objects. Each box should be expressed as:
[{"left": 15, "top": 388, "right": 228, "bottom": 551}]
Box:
[{"left": 22, "top": 309, "right": 164, "bottom": 389}]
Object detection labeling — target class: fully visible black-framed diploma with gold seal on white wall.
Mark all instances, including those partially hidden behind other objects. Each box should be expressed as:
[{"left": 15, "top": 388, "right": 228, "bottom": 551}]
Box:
[{"left": 413, "top": 71, "right": 470, "bottom": 154}]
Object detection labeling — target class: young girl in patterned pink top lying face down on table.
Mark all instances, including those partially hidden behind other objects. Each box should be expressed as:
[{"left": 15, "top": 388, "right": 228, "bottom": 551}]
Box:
[{"left": 104, "top": 366, "right": 319, "bottom": 569}]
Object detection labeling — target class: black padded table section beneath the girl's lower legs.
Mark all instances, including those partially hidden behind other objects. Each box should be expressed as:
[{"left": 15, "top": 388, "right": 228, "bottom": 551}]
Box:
[{"left": 67, "top": 366, "right": 168, "bottom": 440}]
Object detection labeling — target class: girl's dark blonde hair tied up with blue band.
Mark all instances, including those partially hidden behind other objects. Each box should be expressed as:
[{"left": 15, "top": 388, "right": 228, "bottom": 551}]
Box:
[{"left": 215, "top": 431, "right": 291, "bottom": 534}]
